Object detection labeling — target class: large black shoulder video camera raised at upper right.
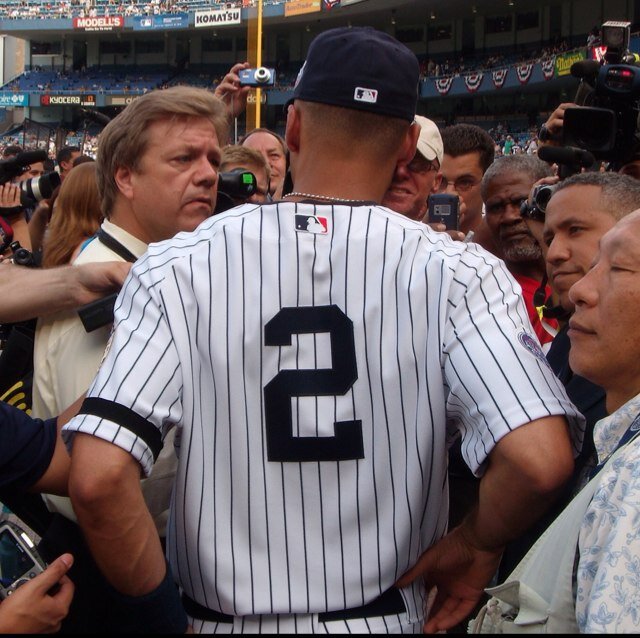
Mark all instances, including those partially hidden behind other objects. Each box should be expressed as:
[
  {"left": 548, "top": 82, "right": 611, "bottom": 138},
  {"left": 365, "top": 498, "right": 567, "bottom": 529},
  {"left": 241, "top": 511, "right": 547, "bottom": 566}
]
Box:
[{"left": 562, "top": 21, "right": 640, "bottom": 167}]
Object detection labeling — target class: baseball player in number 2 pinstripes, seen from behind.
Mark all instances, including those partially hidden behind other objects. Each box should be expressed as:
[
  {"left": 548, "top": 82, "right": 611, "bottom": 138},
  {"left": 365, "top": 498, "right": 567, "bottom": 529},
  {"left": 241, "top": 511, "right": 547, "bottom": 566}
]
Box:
[{"left": 64, "top": 28, "right": 581, "bottom": 633}]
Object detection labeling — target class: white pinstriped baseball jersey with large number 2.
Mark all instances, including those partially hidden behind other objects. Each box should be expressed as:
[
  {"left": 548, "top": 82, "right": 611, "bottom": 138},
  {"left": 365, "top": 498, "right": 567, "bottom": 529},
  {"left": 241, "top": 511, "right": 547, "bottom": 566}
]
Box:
[{"left": 65, "top": 202, "right": 581, "bottom": 615}]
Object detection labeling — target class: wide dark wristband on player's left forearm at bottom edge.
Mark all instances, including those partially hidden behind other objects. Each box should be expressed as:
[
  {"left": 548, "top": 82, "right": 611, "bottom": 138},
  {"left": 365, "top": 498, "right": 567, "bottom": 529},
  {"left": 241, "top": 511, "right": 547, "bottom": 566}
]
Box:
[{"left": 109, "top": 563, "right": 189, "bottom": 634}]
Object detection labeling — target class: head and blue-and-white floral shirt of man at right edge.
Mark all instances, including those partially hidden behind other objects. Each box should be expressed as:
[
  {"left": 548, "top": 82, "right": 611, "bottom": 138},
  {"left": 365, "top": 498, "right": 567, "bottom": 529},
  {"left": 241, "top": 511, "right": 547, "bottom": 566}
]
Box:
[{"left": 568, "top": 211, "right": 640, "bottom": 633}]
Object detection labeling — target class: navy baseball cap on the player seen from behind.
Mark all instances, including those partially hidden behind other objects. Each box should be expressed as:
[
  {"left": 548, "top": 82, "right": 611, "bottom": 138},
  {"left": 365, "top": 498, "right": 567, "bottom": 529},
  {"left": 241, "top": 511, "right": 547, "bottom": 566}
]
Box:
[{"left": 293, "top": 27, "right": 420, "bottom": 122}]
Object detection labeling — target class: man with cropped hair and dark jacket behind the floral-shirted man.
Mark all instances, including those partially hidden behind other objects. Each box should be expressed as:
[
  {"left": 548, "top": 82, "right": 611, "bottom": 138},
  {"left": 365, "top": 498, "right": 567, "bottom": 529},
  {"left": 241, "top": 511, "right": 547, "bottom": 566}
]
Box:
[{"left": 499, "top": 172, "right": 640, "bottom": 579}]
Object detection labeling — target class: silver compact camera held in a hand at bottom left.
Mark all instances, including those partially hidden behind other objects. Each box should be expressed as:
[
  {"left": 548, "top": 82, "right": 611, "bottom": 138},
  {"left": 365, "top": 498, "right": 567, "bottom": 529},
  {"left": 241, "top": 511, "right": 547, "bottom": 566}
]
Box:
[{"left": 0, "top": 521, "right": 47, "bottom": 599}]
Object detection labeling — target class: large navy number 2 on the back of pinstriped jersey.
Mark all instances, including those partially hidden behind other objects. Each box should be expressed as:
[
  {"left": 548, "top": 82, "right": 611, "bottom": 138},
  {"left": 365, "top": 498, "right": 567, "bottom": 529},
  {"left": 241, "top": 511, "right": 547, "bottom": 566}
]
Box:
[{"left": 264, "top": 305, "right": 364, "bottom": 463}]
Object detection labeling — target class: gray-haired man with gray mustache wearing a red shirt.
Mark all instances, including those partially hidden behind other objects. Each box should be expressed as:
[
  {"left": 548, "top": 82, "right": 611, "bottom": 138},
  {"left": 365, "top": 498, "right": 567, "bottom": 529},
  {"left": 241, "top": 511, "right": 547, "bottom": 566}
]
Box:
[{"left": 481, "top": 154, "right": 553, "bottom": 346}]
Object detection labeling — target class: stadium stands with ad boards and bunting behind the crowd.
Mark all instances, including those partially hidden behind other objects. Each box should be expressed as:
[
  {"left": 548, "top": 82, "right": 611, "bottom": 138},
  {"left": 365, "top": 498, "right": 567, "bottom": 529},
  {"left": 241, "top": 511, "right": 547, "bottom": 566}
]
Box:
[{"left": 0, "top": 0, "right": 638, "bottom": 133}]
